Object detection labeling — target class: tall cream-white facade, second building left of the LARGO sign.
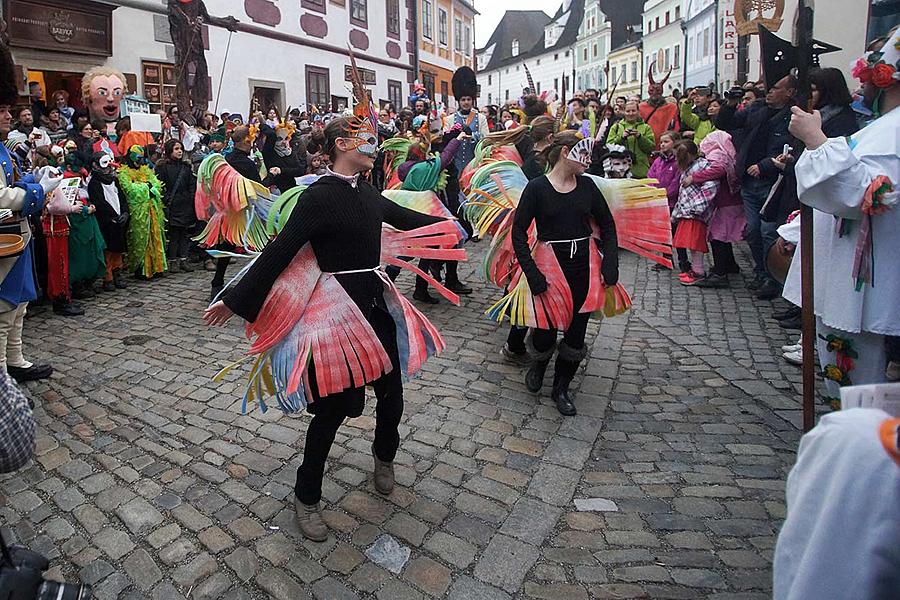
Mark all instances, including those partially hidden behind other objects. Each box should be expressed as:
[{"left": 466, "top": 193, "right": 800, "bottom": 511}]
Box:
[{"left": 642, "top": 0, "right": 684, "bottom": 94}]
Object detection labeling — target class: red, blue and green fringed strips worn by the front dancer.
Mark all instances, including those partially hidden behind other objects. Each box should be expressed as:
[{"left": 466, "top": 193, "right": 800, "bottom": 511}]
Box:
[{"left": 216, "top": 185, "right": 466, "bottom": 413}]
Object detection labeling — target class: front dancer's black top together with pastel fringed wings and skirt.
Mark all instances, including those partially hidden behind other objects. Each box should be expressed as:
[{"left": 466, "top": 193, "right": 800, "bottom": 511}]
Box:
[{"left": 217, "top": 176, "right": 465, "bottom": 416}]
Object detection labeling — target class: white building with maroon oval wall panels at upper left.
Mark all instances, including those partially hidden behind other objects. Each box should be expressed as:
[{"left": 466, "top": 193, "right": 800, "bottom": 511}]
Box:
[{"left": 6, "top": 0, "right": 415, "bottom": 115}]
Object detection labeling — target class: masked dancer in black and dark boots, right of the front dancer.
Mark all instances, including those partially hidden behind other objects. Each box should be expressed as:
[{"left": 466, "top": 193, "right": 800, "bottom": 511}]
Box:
[{"left": 512, "top": 131, "right": 619, "bottom": 415}]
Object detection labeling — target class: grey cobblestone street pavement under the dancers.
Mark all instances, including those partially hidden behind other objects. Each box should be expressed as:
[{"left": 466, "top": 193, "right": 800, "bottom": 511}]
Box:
[{"left": 0, "top": 244, "right": 816, "bottom": 600}]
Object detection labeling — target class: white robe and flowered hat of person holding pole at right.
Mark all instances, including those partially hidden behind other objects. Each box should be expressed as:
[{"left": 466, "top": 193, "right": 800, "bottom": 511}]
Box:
[{"left": 784, "top": 35, "right": 900, "bottom": 398}]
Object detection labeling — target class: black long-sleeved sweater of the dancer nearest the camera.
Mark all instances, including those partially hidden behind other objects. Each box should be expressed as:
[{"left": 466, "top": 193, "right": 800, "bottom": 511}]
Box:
[{"left": 223, "top": 176, "right": 441, "bottom": 322}]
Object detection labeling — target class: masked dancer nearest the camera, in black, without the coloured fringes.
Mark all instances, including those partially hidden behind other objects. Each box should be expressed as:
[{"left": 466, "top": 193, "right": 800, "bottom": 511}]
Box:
[{"left": 205, "top": 117, "right": 441, "bottom": 541}]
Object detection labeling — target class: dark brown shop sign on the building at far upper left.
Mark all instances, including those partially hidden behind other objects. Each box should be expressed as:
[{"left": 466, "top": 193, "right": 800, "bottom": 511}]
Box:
[{"left": 3, "top": 0, "right": 115, "bottom": 56}]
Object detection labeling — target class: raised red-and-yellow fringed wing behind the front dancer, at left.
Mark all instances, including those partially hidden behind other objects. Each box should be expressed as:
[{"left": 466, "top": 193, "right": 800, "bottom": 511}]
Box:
[{"left": 194, "top": 154, "right": 272, "bottom": 252}]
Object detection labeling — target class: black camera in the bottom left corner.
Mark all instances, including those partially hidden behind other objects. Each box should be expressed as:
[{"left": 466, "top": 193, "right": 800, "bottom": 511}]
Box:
[{"left": 0, "top": 538, "right": 93, "bottom": 600}]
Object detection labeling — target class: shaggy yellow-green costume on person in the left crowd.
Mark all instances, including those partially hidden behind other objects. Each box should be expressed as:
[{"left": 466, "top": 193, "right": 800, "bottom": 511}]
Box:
[{"left": 118, "top": 165, "right": 167, "bottom": 278}]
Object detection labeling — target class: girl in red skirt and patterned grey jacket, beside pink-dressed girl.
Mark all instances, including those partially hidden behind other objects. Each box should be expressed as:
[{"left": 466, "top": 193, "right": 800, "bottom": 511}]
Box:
[{"left": 672, "top": 140, "right": 719, "bottom": 285}]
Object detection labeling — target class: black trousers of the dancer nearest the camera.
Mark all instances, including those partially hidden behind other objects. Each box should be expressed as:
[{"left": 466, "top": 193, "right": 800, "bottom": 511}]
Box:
[{"left": 294, "top": 307, "right": 403, "bottom": 505}]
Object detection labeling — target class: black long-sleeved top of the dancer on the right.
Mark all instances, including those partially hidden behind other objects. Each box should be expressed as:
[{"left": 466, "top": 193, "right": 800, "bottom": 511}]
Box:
[{"left": 512, "top": 175, "right": 619, "bottom": 294}]
